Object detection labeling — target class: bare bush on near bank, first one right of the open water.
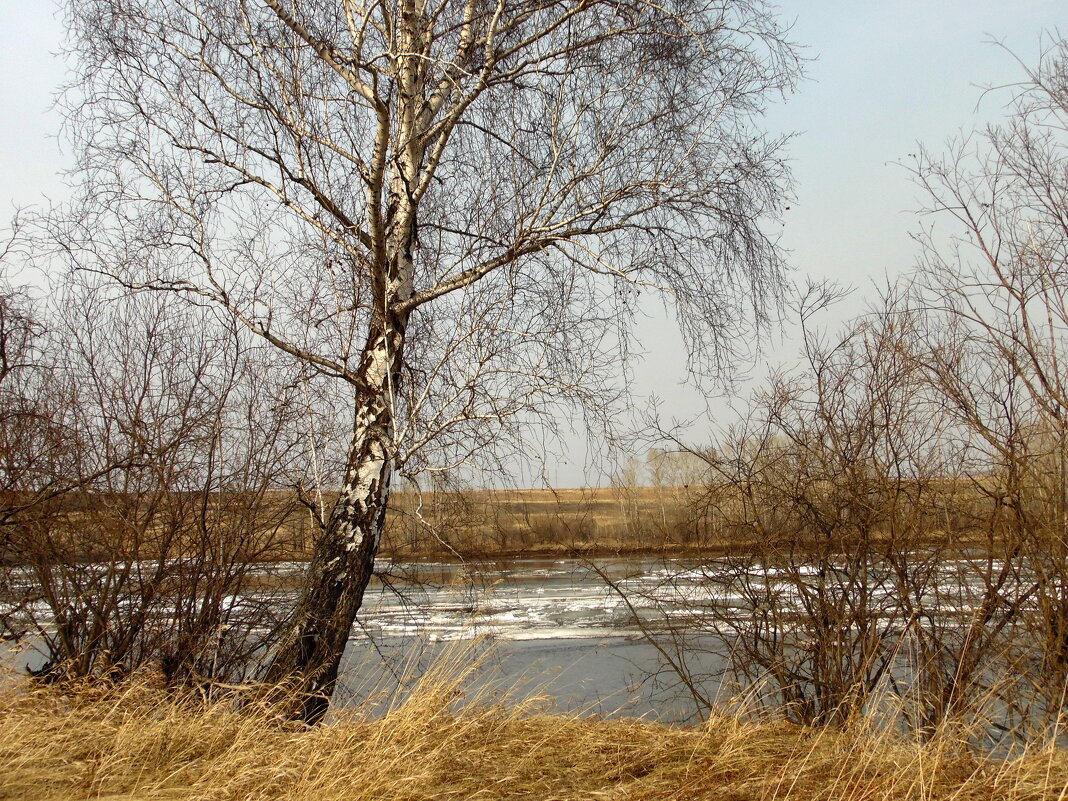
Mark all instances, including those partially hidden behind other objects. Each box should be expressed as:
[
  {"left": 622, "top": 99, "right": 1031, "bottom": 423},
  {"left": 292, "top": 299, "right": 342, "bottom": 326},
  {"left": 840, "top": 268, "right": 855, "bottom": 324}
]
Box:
[{"left": 679, "top": 295, "right": 965, "bottom": 723}]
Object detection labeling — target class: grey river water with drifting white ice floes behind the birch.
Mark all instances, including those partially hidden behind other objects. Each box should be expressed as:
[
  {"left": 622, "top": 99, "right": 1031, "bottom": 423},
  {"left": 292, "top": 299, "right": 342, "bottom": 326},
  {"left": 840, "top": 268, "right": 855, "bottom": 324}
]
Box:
[{"left": 6, "top": 556, "right": 1025, "bottom": 723}]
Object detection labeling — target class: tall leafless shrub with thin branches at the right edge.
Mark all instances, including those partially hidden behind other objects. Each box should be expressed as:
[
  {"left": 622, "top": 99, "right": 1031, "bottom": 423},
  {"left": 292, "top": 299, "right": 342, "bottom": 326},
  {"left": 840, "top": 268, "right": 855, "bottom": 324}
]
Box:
[{"left": 914, "top": 40, "right": 1068, "bottom": 720}]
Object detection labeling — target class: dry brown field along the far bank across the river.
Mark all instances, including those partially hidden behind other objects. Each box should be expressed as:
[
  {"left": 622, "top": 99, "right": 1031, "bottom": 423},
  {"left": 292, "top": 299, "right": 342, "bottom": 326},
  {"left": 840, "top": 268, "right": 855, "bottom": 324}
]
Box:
[{"left": 16, "top": 481, "right": 987, "bottom": 563}]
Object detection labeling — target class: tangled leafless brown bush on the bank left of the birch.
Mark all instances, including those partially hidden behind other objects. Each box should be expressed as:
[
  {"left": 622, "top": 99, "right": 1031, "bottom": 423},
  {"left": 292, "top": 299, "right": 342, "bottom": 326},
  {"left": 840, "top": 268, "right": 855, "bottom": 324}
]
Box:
[{"left": 0, "top": 279, "right": 313, "bottom": 681}]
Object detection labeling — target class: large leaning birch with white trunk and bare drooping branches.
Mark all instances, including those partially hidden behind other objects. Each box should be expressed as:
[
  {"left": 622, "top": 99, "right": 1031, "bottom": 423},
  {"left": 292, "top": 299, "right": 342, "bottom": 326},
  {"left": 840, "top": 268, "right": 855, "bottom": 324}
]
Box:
[{"left": 56, "top": 0, "right": 798, "bottom": 720}]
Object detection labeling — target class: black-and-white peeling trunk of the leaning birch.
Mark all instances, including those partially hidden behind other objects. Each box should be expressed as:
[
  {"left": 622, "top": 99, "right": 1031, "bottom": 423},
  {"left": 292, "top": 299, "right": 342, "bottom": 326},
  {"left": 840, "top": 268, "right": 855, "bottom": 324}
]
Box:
[{"left": 266, "top": 29, "right": 425, "bottom": 723}]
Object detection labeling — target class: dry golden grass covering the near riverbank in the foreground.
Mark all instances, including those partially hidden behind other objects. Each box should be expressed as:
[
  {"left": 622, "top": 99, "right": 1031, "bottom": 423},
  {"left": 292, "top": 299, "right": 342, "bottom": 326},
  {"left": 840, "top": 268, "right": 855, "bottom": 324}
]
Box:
[{"left": 0, "top": 676, "right": 1068, "bottom": 801}]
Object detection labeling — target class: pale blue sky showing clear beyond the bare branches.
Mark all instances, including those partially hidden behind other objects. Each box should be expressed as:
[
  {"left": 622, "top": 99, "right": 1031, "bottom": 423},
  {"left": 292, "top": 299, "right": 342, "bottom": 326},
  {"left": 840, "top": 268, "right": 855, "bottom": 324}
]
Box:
[{"left": 0, "top": 0, "right": 1066, "bottom": 486}]
